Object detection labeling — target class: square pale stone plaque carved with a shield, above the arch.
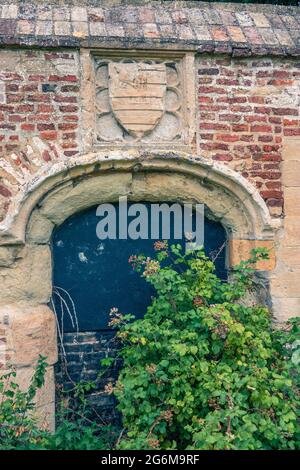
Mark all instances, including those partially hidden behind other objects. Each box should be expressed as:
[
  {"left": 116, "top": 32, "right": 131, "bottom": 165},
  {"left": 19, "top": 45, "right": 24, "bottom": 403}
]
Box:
[{"left": 95, "top": 57, "right": 185, "bottom": 147}]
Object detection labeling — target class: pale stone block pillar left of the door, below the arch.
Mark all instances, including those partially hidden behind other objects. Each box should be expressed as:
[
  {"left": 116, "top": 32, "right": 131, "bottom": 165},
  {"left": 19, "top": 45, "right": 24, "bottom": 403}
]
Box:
[{"left": 0, "top": 245, "right": 57, "bottom": 431}]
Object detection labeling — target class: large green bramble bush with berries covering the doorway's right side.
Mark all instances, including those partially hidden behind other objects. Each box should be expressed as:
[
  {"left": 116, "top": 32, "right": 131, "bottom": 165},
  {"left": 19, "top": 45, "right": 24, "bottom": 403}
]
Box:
[{"left": 105, "top": 242, "right": 300, "bottom": 450}]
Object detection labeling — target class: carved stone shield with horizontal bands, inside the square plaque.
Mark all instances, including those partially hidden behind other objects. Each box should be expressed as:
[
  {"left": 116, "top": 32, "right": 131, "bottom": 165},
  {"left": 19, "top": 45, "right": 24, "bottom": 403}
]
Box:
[{"left": 108, "top": 63, "right": 167, "bottom": 137}]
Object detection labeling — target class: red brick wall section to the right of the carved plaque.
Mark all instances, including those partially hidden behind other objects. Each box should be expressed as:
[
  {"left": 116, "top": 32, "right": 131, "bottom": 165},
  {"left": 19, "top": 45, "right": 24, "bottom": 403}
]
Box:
[{"left": 198, "top": 57, "right": 300, "bottom": 216}]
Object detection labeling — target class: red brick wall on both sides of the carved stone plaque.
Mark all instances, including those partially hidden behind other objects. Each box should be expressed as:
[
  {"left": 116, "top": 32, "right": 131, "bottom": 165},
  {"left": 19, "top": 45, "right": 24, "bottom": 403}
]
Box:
[{"left": 0, "top": 49, "right": 300, "bottom": 219}]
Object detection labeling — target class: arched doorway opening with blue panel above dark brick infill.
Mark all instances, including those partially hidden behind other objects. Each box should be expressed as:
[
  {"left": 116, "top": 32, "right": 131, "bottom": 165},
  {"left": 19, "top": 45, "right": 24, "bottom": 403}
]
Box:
[{"left": 52, "top": 203, "right": 226, "bottom": 422}]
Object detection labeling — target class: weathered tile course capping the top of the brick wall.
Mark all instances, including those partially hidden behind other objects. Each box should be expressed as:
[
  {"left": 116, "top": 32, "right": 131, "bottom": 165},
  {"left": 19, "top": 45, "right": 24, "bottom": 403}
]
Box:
[{"left": 0, "top": 0, "right": 300, "bottom": 56}]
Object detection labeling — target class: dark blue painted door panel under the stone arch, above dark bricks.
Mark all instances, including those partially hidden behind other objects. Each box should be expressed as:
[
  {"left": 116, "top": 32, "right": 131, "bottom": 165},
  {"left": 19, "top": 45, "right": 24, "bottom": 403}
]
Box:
[{"left": 52, "top": 204, "right": 226, "bottom": 332}]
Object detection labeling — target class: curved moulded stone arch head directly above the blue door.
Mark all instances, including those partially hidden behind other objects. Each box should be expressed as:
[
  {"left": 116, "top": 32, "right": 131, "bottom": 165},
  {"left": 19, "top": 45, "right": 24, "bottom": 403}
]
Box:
[{"left": 0, "top": 150, "right": 280, "bottom": 245}]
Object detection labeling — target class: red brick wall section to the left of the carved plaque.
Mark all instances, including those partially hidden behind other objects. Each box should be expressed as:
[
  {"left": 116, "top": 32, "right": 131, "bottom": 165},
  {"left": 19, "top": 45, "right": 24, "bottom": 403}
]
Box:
[{"left": 0, "top": 51, "right": 79, "bottom": 161}]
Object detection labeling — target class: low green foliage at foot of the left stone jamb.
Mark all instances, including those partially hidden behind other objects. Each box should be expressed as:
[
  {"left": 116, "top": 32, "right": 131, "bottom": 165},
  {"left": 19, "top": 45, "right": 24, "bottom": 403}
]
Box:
[{"left": 0, "top": 356, "right": 119, "bottom": 450}]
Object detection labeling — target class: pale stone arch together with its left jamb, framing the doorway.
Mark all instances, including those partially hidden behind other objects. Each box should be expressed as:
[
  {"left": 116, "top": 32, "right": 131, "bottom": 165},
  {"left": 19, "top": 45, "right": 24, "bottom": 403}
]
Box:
[{"left": 0, "top": 150, "right": 276, "bottom": 428}]
